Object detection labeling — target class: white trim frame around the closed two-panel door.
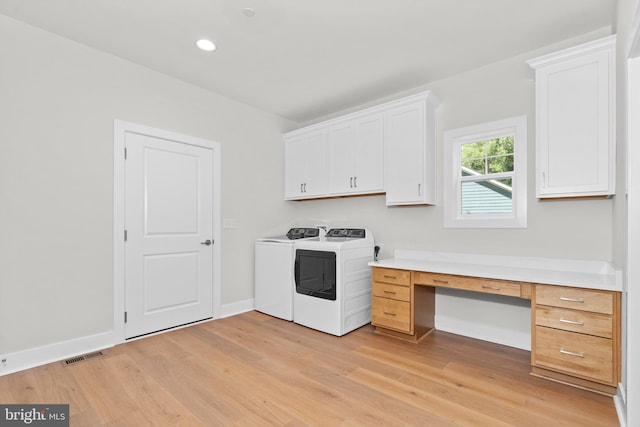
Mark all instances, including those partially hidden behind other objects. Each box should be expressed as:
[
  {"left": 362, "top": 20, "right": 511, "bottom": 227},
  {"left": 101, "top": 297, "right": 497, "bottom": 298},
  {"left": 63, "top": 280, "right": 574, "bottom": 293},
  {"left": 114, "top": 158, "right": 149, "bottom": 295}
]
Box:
[{"left": 113, "top": 119, "right": 222, "bottom": 345}]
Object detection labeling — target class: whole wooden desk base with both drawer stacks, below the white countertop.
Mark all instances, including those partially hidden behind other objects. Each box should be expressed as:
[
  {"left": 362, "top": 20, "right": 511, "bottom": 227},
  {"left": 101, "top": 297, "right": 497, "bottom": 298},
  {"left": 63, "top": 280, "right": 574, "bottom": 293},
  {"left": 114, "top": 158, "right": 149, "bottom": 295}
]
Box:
[{"left": 371, "top": 267, "right": 620, "bottom": 395}]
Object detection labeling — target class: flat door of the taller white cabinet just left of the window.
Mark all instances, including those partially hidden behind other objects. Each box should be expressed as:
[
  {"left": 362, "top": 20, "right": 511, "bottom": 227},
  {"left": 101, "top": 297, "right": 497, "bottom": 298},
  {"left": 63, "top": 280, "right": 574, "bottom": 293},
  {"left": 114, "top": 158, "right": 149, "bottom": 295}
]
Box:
[{"left": 384, "top": 102, "right": 426, "bottom": 205}]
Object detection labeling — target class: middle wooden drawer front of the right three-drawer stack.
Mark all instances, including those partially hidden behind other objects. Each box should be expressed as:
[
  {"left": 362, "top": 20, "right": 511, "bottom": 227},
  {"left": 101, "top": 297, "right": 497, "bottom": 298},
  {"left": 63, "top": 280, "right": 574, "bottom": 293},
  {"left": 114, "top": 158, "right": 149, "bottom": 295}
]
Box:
[{"left": 536, "top": 306, "right": 613, "bottom": 338}]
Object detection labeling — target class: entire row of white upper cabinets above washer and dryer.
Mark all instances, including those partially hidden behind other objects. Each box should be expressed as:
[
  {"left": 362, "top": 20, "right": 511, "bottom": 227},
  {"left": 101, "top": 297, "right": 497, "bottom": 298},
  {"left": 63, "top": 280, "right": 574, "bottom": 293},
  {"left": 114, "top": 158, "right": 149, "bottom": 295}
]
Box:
[{"left": 284, "top": 91, "right": 439, "bottom": 205}]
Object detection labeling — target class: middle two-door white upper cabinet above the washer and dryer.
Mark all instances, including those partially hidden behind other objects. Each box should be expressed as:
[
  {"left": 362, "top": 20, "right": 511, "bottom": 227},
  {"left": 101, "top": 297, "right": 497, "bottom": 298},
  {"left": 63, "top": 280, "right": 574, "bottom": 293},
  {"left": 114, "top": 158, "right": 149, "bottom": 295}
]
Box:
[{"left": 327, "top": 113, "right": 384, "bottom": 196}]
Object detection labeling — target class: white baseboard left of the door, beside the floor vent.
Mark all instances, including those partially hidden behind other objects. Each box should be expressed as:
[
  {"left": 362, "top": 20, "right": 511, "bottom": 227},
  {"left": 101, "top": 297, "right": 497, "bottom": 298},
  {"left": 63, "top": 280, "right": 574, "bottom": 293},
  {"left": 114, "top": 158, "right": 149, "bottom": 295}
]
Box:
[{"left": 0, "top": 331, "right": 115, "bottom": 376}]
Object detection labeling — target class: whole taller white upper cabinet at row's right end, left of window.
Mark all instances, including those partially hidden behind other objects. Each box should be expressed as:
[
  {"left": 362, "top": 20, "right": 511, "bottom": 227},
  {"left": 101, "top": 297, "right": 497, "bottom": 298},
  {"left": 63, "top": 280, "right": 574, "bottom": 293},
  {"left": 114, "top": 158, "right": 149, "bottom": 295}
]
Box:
[{"left": 384, "top": 92, "right": 439, "bottom": 206}]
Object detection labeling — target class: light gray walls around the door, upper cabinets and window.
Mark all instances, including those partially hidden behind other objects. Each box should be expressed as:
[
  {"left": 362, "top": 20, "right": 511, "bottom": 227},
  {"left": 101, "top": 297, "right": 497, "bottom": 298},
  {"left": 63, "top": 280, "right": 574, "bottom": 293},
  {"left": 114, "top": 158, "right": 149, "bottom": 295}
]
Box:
[{"left": 0, "top": 16, "right": 613, "bottom": 355}]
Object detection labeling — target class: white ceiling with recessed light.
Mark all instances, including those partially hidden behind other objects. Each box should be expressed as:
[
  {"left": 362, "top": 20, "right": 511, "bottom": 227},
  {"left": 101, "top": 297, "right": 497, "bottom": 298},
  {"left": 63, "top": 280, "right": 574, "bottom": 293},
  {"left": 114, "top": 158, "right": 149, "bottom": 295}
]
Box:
[{"left": 0, "top": 0, "right": 615, "bottom": 122}]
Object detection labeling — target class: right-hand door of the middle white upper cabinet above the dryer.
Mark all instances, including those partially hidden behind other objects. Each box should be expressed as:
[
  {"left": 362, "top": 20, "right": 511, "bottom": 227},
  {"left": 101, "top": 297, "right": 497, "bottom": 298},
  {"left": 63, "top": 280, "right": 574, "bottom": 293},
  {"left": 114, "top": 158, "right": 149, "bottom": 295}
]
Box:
[{"left": 352, "top": 113, "right": 384, "bottom": 193}]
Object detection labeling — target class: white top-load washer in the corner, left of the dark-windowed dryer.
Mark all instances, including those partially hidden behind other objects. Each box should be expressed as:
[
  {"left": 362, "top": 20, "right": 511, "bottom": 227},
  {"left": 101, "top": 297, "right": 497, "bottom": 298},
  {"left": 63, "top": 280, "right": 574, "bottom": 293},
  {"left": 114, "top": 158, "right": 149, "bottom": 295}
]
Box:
[{"left": 254, "top": 228, "right": 324, "bottom": 321}]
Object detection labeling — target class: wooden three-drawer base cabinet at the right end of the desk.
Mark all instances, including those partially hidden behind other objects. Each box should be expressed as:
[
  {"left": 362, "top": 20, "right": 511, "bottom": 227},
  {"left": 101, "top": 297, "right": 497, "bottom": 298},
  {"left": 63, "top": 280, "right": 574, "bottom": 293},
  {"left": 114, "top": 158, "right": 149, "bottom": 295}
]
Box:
[{"left": 531, "top": 285, "right": 620, "bottom": 394}]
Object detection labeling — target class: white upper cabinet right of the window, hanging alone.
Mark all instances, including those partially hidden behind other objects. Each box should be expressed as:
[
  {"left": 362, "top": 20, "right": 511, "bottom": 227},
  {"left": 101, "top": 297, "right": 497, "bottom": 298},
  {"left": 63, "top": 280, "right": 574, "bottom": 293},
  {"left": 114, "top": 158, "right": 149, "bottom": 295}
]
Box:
[{"left": 528, "top": 36, "right": 616, "bottom": 198}]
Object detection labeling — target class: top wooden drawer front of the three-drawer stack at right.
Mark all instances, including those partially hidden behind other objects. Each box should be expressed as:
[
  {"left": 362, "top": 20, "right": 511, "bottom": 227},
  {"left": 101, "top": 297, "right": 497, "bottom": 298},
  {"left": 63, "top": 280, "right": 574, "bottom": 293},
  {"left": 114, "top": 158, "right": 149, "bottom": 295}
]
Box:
[{"left": 536, "top": 285, "right": 613, "bottom": 314}]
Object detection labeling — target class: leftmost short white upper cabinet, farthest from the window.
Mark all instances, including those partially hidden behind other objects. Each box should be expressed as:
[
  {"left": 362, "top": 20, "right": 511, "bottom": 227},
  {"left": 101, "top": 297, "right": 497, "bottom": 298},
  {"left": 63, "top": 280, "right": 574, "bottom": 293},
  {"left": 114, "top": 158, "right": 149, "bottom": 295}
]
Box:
[{"left": 284, "top": 129, "right": 327, "bottom": 200}]
